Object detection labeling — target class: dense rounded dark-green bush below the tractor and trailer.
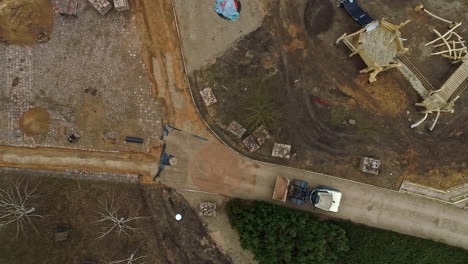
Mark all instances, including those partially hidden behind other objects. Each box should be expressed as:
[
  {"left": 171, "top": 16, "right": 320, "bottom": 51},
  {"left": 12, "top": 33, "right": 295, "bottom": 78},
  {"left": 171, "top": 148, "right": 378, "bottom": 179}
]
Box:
[{"left": 226, "top": 199, "right": 348, "bottom": 264}]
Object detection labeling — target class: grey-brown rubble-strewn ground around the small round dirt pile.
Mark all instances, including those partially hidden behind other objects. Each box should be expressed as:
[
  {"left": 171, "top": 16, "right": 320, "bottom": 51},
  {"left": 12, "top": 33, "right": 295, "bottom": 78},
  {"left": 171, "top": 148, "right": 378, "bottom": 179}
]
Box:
[{"left": 0, "top": 1, "right": 164, "bottom": 152}]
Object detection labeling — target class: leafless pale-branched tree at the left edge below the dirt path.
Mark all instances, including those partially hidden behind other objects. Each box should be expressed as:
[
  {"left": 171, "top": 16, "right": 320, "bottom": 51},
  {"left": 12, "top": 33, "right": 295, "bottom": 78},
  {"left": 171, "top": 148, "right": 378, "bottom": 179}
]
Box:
[{"left": 0, "top": 179, "right": 43, "bottom": 238}]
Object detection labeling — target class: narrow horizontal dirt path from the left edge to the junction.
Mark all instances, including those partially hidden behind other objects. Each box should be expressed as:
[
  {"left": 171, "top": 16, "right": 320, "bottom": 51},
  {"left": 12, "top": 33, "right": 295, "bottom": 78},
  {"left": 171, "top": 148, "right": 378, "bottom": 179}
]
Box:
[{"left": 0, "top": 146, "right": 160, "bottom": 180}]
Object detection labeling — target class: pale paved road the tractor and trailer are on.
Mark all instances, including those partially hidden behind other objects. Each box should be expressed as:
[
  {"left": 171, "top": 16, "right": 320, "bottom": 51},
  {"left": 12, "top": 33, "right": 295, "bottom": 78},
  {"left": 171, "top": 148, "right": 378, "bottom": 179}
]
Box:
[{"left": 161, "top": 131, "right": 468, "bottom": 249}]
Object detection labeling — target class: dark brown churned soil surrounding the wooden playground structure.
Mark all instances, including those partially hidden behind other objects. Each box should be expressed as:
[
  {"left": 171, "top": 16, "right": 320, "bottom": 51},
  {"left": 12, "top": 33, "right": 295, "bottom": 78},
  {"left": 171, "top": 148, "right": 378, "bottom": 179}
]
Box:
[{"left": 188, "top": 1, "right": 468, "bottom": 189}]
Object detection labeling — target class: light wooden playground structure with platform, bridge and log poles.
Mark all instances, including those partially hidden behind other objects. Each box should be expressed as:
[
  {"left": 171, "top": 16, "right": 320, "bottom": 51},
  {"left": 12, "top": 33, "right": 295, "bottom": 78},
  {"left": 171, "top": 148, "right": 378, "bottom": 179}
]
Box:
[{"left": 336, "top": 12, "right": 468, "bottom": 131}]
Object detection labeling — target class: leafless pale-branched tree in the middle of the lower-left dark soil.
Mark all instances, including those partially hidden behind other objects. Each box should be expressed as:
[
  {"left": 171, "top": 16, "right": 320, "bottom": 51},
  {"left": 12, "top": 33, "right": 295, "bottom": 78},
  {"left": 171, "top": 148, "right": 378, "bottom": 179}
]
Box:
[{"left": 96, "top": 194, "right": 147, "bottom": 239}]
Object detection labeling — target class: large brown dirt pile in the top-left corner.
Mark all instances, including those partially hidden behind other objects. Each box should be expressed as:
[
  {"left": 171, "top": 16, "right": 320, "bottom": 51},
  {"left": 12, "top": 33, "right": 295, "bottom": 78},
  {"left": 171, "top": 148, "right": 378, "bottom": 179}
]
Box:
[{"left": 0, "top": 0, "right": 54, "bottom": 45}]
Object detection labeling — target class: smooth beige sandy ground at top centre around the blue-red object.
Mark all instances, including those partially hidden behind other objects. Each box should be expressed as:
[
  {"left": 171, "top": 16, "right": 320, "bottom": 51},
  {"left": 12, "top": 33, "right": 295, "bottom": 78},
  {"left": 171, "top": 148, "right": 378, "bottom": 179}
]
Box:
[{"left": 174, "top": 0, "right": 265, "bottom": 74}]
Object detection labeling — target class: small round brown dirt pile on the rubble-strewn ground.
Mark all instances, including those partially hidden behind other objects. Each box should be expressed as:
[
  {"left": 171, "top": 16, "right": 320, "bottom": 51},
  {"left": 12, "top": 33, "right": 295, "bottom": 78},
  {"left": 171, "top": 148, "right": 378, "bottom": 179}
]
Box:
[{"left": 20, "top": 107, "right": 50, "bottom": 136}]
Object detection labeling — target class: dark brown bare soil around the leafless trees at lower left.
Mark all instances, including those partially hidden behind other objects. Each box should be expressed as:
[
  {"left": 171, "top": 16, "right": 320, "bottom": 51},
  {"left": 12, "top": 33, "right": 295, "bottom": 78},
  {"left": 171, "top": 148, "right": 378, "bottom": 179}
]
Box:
[{"left": 0, "top": 175, "right": 231, "bottom": 264}]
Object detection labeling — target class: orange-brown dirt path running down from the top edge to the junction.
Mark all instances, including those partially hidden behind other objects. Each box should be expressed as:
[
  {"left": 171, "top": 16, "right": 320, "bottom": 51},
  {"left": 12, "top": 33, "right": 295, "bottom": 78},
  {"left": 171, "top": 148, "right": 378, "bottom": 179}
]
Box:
[{"left": 134, "top": 0, "right": 217, "bottom": 141}]
